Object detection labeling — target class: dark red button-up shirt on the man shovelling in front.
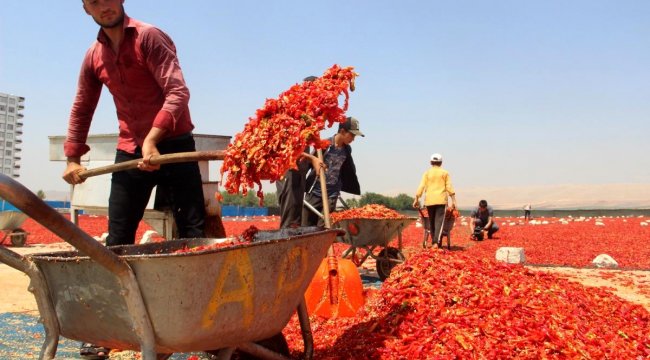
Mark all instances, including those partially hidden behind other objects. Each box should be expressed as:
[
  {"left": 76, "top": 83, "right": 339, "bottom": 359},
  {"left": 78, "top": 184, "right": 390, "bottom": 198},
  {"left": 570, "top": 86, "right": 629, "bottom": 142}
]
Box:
[{"left": 64, "top": 15, "right": 194, "bottom": 157}]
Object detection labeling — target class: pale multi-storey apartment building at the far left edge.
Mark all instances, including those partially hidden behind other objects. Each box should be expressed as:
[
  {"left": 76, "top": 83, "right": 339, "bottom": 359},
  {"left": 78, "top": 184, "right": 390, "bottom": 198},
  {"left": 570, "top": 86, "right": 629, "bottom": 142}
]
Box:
[{"left": 0, "top": 93, "right": 25, "bottom": 178}]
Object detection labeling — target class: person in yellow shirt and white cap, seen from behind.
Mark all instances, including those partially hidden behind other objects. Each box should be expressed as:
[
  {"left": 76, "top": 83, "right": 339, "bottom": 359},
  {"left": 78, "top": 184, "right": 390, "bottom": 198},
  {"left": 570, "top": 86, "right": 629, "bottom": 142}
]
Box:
[{"left": 413, "top": 153, "right": 456, "bottom": 248}]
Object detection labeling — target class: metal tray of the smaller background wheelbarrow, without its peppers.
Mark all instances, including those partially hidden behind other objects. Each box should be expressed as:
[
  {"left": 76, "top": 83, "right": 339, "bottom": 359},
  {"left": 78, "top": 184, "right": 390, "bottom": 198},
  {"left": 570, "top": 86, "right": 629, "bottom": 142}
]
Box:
[{"left": 332, "top": 217, "right": 417, "bottom": 247}]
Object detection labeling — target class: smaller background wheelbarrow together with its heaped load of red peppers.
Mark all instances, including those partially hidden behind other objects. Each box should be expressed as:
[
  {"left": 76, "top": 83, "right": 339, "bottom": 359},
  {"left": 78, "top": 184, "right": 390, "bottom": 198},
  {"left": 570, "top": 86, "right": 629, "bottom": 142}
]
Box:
[{"left": 331, "top": 204, "right": 417, "bottom": 281}]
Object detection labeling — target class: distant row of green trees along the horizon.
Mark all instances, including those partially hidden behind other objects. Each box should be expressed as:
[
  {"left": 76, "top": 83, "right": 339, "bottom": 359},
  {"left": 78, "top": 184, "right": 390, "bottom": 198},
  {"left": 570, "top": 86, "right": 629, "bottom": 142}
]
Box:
[{"left": 215, "top": 191, "right": 413, "bottom": 210}]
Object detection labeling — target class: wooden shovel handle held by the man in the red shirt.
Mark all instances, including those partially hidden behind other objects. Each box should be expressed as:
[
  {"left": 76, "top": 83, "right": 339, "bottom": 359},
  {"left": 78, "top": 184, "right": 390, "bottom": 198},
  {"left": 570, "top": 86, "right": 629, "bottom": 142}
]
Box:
[{"left": 79, "top": 150, "right": 225, "bottom": 179}]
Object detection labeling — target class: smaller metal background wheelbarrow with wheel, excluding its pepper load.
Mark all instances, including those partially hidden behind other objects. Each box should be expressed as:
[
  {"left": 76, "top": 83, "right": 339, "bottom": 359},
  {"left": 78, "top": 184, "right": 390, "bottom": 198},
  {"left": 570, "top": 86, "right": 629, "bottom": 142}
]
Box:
[{"left": 332, "top": 217, "right": 417, "bottom": 281}]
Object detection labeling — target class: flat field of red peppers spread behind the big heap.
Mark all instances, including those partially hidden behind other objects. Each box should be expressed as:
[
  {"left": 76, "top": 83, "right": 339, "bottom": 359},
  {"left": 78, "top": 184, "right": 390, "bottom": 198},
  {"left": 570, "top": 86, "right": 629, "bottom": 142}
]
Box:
[{"left": 17, "top": 215, "right": 650, "bottom": 270}]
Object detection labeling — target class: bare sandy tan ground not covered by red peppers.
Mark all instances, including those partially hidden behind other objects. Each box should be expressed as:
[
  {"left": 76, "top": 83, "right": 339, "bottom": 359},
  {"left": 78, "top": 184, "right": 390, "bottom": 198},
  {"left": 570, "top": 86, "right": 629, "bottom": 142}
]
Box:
[{"left": 0, "top": 243, "right": 650, "bottom": 315}]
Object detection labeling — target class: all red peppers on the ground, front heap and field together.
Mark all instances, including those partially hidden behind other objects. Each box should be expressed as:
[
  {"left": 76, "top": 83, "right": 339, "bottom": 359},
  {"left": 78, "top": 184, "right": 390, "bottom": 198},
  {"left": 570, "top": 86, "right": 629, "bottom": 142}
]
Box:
[{"left": 12, "top": 215, "right": 650, "bottom": 359}]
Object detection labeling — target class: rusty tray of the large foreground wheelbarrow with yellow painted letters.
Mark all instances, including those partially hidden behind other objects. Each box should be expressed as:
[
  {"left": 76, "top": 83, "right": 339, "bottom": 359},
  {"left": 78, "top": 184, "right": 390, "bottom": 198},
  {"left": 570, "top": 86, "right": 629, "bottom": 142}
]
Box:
[{"left": 31, "top": 228, "right": 340, "bottom": 353}]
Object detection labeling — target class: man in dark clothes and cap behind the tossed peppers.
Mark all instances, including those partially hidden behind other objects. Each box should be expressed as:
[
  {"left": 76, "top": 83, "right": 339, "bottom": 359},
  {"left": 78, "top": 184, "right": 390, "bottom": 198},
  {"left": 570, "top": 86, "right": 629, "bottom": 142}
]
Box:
[{"left": 302, "top": 117, "right": 365, "bottom": 226}]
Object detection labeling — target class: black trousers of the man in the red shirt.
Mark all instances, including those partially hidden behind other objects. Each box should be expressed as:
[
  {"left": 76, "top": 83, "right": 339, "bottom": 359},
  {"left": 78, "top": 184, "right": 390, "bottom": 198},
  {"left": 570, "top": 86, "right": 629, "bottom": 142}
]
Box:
[{"left": 106, "top": 134, "right": 205, "bottom": 246}]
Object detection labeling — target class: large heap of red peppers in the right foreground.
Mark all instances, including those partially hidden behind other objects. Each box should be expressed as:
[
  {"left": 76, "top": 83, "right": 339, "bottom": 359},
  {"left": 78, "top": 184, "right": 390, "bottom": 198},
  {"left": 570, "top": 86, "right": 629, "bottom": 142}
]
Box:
[{"left": 285, "top": 250, "right": 650, "bottom": 359}]
